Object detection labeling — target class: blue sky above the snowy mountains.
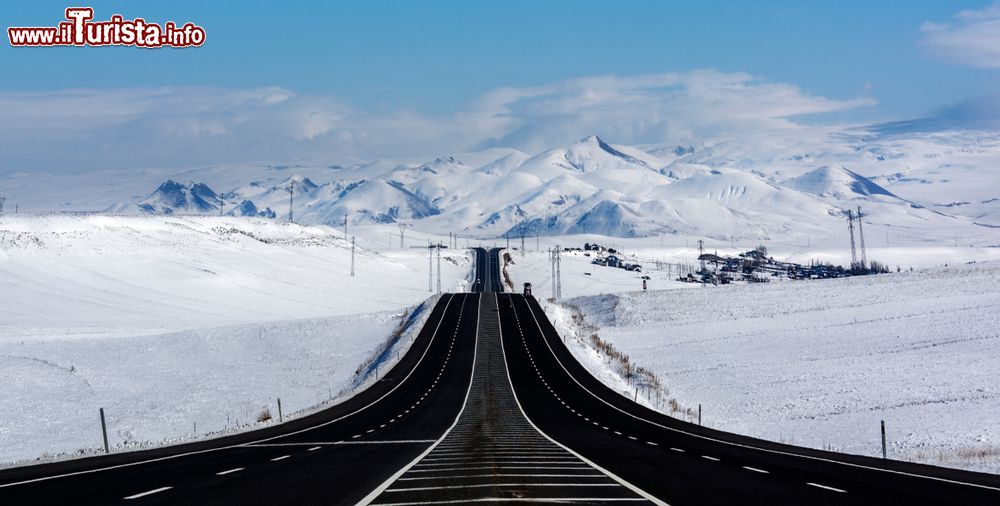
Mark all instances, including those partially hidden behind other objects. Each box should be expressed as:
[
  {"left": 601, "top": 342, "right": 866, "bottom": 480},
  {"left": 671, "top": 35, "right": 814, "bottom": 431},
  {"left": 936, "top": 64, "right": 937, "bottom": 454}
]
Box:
[{"left": 0, "top": 0, "right": 1000, "bottom": 170}]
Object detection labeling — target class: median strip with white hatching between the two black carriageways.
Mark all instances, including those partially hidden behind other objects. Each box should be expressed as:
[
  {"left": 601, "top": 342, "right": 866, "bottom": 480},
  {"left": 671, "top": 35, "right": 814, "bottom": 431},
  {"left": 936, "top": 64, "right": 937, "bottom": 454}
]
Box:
[{"left": 366, "top": 251, "right": 655, "bottom": 505}]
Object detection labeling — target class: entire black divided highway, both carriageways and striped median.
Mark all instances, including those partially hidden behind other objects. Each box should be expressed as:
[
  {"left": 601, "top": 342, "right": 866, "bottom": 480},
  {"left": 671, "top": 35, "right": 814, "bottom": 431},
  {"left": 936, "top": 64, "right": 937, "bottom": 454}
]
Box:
[{"left": 0, "top": 249, "right": 1000, "bottom": 505}]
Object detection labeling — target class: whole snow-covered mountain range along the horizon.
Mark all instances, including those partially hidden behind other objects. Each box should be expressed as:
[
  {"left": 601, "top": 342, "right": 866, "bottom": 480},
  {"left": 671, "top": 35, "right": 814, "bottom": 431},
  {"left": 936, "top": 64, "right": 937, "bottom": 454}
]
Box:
[{"left": 0, "top": 127, "right": 1000, "bottom": 244}]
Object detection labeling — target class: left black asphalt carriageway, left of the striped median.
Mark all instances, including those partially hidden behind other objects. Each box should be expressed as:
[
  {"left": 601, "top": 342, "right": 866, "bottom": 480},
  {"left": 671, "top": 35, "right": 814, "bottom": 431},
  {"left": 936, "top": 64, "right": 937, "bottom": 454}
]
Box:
[{"left": 0, "top": 294, "right": 479, "bottom": 505}]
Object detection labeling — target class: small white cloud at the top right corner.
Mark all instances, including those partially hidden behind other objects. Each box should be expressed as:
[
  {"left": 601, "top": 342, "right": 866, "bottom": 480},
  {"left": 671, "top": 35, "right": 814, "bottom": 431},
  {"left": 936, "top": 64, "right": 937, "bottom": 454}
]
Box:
[{"left": 920, "top": 4, "right": 1000, "bottom": 68}]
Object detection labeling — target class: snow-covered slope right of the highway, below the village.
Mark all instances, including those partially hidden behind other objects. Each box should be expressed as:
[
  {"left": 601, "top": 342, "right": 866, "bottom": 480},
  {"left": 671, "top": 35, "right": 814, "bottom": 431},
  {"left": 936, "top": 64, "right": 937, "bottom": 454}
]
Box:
[{"left": 509, "top": 249, "right": 1000, "bottom": 472}]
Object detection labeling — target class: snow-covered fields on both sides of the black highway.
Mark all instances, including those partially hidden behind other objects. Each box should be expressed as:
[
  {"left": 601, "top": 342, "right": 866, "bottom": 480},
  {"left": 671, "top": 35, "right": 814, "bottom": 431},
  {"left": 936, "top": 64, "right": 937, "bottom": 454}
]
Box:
[{"left": 0, "top": 215, "right": 1000, "bottom": 472}]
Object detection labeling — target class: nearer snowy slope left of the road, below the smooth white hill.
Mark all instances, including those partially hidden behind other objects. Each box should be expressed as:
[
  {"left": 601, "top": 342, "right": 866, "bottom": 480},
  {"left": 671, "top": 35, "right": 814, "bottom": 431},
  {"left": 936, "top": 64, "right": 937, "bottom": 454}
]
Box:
[{"left": 0, "top": 313, "right": 399, "bottom": 462}]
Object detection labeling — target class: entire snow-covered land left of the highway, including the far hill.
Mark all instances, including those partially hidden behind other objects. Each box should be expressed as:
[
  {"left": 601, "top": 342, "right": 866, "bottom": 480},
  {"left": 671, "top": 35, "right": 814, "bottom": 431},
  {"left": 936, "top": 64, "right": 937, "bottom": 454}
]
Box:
[{"left": 0, "top": 216, "right": 470, "bottom": 463}]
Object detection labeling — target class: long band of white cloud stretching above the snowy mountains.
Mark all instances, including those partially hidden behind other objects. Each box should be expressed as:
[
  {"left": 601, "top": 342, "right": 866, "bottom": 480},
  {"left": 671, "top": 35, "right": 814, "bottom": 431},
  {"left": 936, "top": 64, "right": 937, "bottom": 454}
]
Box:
[{"left": 0, "top": 70, "right": 874, "bottom": 171}]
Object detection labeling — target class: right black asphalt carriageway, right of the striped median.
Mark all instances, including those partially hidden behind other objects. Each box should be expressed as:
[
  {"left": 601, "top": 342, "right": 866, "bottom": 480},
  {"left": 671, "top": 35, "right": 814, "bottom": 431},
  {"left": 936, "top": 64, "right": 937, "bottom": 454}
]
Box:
[{"left": 500, "top": 278, "right": 1000, "bottom": 505}]
